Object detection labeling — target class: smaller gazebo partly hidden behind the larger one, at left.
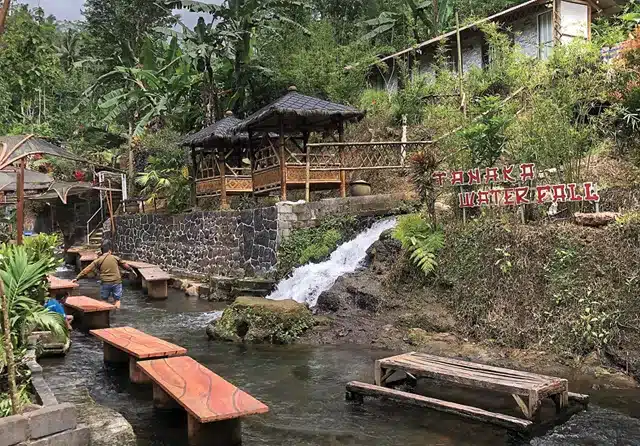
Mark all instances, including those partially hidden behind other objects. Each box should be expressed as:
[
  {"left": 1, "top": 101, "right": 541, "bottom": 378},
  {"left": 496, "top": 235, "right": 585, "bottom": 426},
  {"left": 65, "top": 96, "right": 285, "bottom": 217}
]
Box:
[{"left": 182, "top": 112, "right": 253, "bottom": 208}]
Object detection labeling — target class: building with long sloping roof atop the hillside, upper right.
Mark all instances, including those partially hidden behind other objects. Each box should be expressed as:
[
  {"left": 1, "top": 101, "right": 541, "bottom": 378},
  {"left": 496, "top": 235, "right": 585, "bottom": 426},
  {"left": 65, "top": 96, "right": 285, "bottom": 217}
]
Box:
[{"left": 370, "top": 0, "right": 626, "bottom": 91}]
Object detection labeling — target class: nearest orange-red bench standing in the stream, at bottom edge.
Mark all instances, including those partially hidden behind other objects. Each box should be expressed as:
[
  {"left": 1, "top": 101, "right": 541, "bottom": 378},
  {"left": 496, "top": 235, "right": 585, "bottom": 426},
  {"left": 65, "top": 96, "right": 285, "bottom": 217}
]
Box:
[{"left": 138, "top": 356, "right": 269, "bottom": 446}]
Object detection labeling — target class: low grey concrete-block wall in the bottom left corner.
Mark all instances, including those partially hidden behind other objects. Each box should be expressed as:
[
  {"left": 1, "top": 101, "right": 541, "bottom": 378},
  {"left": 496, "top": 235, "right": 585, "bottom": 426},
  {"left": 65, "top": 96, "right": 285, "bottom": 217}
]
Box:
[{"left": 0, "top": 352, "right": 91, "bottom": 446}]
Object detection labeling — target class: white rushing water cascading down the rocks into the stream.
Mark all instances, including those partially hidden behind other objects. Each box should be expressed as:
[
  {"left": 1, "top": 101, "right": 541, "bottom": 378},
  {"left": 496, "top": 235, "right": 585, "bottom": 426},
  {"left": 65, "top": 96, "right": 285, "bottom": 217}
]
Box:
[{"left": 267, "top": 219, "right": 396, "bottom": 307}]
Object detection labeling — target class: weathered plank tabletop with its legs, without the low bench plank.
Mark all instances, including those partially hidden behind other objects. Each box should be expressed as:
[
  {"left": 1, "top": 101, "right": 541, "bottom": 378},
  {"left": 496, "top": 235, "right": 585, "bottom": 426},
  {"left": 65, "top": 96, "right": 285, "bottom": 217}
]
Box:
[{"left": 374, "top": 352, "right": 569, "bottom": 420}]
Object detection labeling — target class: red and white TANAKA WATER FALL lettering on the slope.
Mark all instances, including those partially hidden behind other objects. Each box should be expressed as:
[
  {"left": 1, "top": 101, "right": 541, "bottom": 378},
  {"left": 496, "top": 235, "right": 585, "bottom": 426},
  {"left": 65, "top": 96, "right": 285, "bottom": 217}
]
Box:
[{"left": 432, "top": 163, "right": 600, "bottom": 208}]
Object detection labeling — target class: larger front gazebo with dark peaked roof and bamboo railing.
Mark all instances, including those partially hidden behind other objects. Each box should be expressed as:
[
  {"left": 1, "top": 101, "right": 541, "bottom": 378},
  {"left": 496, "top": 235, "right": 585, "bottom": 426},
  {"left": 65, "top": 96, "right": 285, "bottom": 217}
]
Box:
[{"left": 234, "top": 87, "right": 364, "bottom": 200}]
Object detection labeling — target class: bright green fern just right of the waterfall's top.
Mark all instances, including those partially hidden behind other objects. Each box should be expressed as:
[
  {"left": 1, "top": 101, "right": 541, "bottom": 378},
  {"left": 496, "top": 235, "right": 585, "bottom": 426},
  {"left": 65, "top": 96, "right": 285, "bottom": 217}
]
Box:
[{"left": 393, "top": 214, "right": 444, "bottom": 275}]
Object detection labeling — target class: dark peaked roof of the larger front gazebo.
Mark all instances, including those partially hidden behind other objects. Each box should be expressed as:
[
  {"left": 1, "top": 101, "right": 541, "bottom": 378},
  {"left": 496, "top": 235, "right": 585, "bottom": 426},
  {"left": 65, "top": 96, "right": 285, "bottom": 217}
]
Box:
[{"left": 235, "top": 87, "right": 365, "bottom": 133}]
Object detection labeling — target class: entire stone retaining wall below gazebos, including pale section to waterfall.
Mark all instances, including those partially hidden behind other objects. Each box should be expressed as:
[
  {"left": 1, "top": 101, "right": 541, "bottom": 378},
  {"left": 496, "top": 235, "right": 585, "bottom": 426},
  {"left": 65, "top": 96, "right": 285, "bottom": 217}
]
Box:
[{"left": 104, "top": 194, "right": 407, "bottom": 278}]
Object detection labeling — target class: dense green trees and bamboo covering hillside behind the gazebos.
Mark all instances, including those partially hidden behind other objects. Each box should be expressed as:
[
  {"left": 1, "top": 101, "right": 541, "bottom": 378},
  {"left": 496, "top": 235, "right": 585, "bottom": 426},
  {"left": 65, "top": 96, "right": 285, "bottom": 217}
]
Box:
[{"left": 0, "top": 0, "right": 640, "bottom": 207}]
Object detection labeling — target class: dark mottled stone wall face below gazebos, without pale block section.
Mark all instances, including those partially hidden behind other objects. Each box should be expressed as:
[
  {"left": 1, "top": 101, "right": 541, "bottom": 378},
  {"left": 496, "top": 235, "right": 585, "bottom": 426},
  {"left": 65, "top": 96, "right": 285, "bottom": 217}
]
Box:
[{"left": 106, "top": 207, "right": 278, "bottom": 277}]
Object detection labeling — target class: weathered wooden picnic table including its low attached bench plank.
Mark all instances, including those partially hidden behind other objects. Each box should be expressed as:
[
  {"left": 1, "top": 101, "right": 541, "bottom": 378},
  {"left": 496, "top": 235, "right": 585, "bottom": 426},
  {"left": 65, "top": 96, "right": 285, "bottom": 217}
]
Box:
[{"left": 347, "top": 352, "right": 587, "bottom": 430}]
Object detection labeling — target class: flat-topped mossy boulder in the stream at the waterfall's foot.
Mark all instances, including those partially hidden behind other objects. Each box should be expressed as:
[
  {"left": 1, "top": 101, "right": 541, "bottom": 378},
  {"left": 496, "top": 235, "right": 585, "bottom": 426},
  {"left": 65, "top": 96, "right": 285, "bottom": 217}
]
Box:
[{"left": 209, "top": 297, "right": 314, "bottom": 344}]
